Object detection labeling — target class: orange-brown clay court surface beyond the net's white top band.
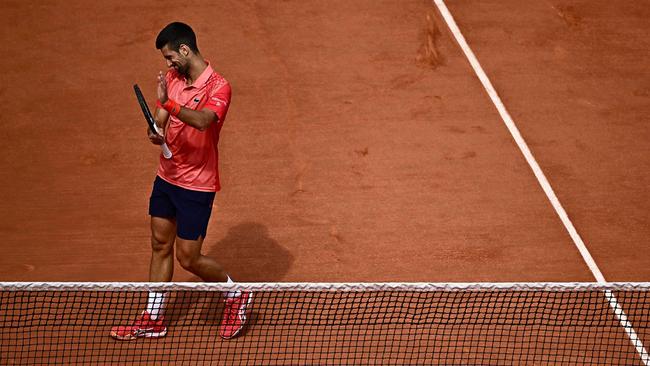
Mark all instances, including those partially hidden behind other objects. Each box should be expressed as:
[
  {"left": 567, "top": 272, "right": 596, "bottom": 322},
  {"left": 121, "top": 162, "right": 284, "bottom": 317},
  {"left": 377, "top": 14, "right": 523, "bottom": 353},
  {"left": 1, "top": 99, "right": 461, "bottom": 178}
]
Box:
[{"left": 0, "top": 0, "right": 650, "bottom": 282}]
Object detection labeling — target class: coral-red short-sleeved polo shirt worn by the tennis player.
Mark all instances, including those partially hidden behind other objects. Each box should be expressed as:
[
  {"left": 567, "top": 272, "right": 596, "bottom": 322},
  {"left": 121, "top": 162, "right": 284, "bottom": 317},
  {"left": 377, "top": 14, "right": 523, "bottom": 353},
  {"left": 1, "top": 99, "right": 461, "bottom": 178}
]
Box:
[{"left": 158, "top": 64, "right": 230, "bottom": 192}]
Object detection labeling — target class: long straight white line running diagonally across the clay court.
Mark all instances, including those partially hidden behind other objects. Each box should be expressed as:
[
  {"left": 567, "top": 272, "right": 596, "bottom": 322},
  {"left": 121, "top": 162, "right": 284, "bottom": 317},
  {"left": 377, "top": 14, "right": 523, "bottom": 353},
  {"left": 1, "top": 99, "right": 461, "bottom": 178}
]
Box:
[{"left": 433, "top": 0, "right": 650, "bottom": 365}]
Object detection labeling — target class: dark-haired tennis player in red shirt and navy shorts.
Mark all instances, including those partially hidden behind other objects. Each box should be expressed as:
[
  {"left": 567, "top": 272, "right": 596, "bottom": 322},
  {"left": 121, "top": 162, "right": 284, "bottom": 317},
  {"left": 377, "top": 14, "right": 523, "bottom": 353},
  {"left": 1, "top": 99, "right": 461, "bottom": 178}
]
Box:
[{"left": 111, "top": 22, "right": 253, "bottom": 340}]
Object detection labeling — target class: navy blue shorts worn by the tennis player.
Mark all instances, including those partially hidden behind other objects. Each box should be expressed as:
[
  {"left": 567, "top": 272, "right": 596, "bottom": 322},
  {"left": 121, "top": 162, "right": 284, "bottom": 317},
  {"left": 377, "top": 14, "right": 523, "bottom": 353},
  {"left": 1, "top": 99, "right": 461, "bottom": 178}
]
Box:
[{"left": 149, "top": 176, "right": 215, "bottom": 240}]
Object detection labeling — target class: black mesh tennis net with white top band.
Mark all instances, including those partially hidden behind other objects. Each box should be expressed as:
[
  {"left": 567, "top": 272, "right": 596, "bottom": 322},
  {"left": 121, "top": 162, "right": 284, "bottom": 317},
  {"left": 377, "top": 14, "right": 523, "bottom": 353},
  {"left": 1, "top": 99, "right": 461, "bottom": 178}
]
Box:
[{"left": 0, "top": 282, "right": 650, "bottom": 365}]
